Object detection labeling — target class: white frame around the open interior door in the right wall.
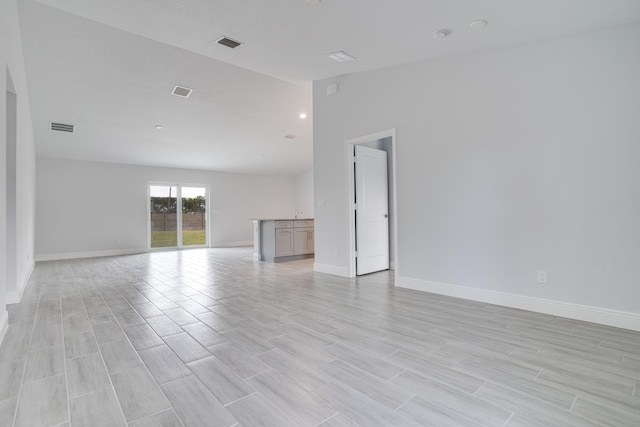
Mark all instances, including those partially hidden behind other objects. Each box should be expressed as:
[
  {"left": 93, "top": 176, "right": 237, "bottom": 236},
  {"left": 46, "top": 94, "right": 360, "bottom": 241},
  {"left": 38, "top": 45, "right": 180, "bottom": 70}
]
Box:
[{"left": 345, "top": 128, "right": 399, "bottom": 277}]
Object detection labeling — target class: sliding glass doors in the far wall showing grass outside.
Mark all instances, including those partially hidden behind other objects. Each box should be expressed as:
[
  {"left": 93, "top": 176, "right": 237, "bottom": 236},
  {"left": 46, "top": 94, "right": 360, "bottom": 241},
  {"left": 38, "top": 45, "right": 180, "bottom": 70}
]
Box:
[{"left": 148, "top": 183, "right": 210, "bottom": 250}]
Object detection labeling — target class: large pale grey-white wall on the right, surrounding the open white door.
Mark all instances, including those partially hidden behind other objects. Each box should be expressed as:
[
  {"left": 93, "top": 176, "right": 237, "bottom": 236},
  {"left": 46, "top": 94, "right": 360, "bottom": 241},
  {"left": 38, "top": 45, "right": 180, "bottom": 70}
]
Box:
[{"left": 313, "top": 25, "right": 640, "bottom": 327}]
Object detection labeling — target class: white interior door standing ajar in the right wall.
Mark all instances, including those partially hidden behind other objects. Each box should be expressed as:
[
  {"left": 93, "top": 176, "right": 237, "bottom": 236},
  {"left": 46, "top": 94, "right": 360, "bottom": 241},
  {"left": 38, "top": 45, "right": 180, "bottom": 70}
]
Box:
[{"left": 355, "top": 145, "right": 389, "bottom": 275}]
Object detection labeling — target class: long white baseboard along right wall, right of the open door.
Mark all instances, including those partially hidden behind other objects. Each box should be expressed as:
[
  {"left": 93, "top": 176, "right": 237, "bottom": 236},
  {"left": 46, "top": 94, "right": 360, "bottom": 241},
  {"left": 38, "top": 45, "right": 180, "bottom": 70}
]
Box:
[{"left": 396, "top": 276, "right": 640, "bottom": 331}]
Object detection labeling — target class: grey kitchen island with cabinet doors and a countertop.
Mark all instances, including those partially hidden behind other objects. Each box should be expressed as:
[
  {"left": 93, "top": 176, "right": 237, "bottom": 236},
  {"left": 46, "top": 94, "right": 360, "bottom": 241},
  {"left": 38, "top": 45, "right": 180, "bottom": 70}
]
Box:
[{"left": 252, "top": 218, "right": 314, "bottom": 262}]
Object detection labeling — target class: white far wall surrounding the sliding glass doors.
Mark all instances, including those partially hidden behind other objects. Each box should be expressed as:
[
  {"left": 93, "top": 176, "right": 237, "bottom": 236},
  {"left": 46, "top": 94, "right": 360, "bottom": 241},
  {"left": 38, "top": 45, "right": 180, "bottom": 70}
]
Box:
[{"left": 36, "top": 158, "right": 296, "bottom": 259}]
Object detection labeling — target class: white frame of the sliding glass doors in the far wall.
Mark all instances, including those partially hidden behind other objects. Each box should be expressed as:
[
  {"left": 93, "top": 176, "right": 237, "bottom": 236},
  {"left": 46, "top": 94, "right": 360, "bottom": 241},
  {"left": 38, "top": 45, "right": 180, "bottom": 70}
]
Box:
[{"left": 146, "top": 181, "right": 211, "bottom": 252}]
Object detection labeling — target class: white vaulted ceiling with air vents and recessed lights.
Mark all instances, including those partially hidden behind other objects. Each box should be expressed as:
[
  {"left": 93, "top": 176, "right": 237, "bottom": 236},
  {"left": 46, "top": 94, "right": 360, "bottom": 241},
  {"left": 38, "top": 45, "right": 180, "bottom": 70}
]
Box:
[{"left": 18, "top": 0, "right": 640, "bottom": 176}]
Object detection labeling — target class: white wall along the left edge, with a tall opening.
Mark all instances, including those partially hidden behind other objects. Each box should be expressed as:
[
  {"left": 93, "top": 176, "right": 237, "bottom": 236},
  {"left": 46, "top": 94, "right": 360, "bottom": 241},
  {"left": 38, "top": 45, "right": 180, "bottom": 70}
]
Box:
[{"left": 0, "top": 0, "right": 35, "bottom": 339}]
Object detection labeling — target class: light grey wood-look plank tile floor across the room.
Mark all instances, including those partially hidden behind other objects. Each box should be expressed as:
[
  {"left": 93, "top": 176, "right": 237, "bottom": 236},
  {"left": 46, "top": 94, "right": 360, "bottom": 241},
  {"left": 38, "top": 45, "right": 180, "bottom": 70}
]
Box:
[{"left": 0, "top": 248, "right": 640, "bottom": 427}]
